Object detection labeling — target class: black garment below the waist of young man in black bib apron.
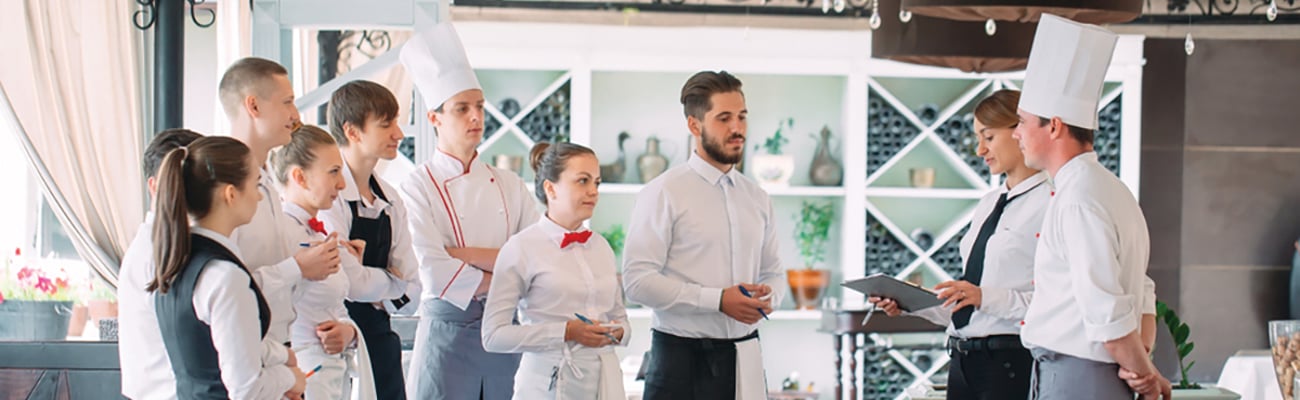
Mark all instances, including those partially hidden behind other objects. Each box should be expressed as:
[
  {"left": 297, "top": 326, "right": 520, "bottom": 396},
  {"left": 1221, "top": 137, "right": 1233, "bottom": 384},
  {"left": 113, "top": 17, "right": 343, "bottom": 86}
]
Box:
[{"left": 343, "top": 301, "right": 406, "bottom": 400}]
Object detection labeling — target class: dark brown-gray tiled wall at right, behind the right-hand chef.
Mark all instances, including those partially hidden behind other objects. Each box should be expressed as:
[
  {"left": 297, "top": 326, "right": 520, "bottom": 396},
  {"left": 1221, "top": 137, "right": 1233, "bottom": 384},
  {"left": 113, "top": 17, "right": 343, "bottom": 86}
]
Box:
[{"left": 1140, "top": 39, "right": 1300, "bottom": 382}]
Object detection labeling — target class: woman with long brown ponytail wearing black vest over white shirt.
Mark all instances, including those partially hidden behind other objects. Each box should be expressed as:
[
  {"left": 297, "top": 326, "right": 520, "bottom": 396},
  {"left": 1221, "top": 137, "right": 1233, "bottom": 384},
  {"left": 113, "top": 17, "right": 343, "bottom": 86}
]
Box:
[{"left": 147, "top": 138, "right": 306, "bottom": 399}]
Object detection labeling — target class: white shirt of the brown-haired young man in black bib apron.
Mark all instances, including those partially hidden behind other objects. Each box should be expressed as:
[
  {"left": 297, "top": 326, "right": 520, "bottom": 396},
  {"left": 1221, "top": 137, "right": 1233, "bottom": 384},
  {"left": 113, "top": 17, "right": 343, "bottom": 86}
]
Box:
[{"left": 317, "top": 157, "right": 420, "bottom": 313}]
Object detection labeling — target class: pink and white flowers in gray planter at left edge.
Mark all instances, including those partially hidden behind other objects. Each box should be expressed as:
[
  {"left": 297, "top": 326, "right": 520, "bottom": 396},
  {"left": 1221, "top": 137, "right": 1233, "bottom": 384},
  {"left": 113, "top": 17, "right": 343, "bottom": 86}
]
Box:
[{"left": 0, "top": 249, "right": 75, "bottom": 340}]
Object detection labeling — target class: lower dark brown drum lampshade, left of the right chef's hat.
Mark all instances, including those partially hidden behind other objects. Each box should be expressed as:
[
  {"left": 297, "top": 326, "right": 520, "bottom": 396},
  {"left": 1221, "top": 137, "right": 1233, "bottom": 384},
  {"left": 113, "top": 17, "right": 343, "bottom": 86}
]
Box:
[{"left": 871, "top": 0, "right": 1037, "bottom": 73}]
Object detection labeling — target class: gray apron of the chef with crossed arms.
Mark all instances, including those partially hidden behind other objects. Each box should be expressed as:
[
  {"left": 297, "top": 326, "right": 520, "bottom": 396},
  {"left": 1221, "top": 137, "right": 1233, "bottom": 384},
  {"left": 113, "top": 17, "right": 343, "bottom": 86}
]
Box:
[{"left": 407, "top": 294, "right": 520, "bottom": 400}]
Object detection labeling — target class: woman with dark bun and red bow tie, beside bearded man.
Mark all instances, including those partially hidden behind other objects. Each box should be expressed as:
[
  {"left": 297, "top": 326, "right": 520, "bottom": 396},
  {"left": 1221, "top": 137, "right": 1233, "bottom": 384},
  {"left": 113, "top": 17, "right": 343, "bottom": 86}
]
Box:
[{"left": 482, "top": 143, "right": 628, "bottom": 400}]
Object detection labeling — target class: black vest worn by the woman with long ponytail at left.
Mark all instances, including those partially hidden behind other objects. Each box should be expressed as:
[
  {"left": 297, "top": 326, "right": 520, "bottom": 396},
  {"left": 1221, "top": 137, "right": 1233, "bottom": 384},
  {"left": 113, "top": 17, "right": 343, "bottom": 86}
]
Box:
[{"left": 153, "top": 234, "right": 270, "bottom": 399}]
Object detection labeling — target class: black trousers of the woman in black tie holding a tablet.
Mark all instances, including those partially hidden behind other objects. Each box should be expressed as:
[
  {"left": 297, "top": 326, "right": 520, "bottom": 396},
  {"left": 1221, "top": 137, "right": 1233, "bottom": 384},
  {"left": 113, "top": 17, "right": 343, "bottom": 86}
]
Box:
[{"left": 948, "top": 340, "right": 1034, "bottom": 400}]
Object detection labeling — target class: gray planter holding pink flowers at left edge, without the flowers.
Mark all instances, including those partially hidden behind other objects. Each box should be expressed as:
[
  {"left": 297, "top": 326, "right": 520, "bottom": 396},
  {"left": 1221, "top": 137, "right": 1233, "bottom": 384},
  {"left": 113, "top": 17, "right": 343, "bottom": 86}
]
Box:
[{"left": 0, "top": 300, "right": 73, "bottom": 340}]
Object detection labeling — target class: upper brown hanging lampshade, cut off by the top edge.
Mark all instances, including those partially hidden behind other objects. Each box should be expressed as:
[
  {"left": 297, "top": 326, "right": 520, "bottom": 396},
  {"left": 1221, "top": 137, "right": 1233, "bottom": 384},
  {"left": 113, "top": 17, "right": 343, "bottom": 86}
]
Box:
[{"left": 902, "top": 0, "right": 1143, "bottom": 23}]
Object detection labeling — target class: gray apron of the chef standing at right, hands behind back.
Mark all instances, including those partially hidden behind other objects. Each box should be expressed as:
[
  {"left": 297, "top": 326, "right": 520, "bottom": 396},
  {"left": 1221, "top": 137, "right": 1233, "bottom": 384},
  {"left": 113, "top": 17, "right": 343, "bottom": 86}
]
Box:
[{"left": 1030, "top": 348, "right": 1134, "bottom": 400}]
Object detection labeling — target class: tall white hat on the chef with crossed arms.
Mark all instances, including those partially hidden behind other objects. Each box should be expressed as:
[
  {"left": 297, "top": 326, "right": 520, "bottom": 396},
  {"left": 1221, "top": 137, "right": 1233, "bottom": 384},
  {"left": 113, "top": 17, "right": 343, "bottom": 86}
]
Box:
[{"left": 402, "top": 22, "right": 481, "bottom": 109}]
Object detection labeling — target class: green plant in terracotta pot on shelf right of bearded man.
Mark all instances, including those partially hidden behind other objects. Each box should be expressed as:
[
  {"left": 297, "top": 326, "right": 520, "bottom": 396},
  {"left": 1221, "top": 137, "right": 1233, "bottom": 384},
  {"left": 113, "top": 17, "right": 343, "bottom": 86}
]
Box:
[{"left": 785, "top": 200, "right": 835, "bottom": 309}]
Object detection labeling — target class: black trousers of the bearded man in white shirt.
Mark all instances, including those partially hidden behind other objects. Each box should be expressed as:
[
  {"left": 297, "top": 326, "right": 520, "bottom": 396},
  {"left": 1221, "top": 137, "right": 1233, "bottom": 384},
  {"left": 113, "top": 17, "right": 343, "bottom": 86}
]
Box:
[{"left": 644, "top": 331, "right": 758, "bottom": 400}]
